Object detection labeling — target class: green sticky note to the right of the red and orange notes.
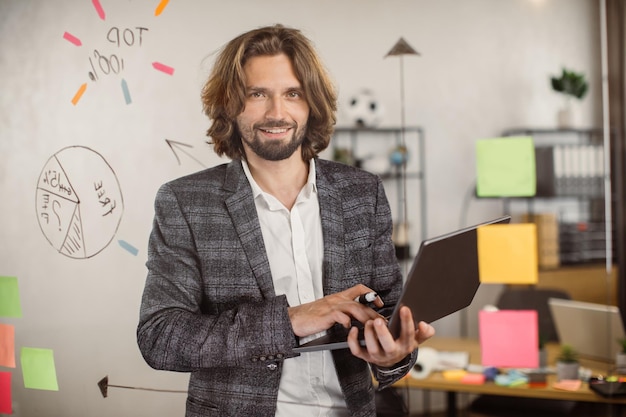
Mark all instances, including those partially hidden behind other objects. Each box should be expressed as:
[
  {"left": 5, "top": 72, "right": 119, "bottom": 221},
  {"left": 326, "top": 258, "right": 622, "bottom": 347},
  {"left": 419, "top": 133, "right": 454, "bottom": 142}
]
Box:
[{"left": 20, "top": 347, "right": 59, "bottom": 391}]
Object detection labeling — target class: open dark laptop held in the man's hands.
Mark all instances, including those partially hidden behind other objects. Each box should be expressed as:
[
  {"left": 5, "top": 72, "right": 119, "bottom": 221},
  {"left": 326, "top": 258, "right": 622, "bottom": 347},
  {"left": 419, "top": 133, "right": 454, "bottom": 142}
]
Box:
[{"left": 294, "top": 216, "right": 511, "bottom": 352}]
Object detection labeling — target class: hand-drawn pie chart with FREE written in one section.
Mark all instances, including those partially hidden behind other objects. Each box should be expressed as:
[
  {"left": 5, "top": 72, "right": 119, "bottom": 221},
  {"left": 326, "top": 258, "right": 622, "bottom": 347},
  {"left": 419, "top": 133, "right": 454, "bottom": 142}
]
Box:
[{"left": 35, "top": 146, "right": 124, "bottom": 259}]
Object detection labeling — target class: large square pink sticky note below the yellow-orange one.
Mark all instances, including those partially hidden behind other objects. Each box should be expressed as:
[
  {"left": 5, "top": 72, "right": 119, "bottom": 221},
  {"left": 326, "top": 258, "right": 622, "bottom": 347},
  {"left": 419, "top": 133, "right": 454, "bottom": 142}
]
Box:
[{"left": 478, "top": 310, "right": 539, "bottom": 368}]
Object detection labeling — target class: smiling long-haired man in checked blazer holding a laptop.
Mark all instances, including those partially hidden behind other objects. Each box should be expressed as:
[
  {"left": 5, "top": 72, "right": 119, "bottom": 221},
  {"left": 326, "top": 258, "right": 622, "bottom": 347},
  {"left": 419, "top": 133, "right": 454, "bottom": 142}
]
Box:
[{"left": 137, "top": 25, "right": 434, "bottom": 417}]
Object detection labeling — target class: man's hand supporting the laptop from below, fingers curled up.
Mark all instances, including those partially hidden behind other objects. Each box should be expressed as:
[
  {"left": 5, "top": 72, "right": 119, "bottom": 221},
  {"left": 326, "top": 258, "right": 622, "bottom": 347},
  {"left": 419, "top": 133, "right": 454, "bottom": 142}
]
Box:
[{"left": 348, "top": 306, "right": 435, "bottom": 367}]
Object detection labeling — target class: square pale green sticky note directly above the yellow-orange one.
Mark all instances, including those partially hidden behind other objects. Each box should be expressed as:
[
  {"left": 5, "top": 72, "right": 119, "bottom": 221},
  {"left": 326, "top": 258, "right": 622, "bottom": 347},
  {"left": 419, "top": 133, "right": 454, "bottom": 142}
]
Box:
[{"left": 476, "top": 136, "right": 537, "bottom": 197}]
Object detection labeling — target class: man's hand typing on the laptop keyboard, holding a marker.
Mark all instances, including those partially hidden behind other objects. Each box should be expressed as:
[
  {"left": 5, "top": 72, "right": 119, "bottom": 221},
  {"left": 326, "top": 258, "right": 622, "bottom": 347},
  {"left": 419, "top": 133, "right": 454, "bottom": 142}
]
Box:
[{"left": 289, "top": 284, "right": 384, "bottom": 337}]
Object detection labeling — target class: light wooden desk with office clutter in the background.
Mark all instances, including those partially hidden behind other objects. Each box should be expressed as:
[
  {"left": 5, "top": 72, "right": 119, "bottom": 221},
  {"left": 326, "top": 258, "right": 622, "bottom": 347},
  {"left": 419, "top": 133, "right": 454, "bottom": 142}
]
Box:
[{"left": 395, "top": 336, "right": 626, "bottom": 416}]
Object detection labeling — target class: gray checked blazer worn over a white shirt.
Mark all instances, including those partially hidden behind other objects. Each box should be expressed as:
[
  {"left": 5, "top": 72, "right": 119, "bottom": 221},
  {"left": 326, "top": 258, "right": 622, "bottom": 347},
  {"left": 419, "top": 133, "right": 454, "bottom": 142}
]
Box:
[{"left": 137, "top": 160, "right": 417, "bottom": 417}]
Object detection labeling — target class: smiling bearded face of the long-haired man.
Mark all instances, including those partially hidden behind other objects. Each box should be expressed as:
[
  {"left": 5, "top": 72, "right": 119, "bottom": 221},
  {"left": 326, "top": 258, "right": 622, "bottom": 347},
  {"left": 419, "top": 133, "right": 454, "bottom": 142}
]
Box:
[{"left": 237, "top": 54, "right": 309, "bottom": 161}]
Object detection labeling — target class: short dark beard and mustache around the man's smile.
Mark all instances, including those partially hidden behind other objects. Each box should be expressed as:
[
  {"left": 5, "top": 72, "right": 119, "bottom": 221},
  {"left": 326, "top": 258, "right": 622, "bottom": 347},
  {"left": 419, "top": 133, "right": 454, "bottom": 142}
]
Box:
[{"left": 237, "top": 121, "right": 306, "bottom": 161}]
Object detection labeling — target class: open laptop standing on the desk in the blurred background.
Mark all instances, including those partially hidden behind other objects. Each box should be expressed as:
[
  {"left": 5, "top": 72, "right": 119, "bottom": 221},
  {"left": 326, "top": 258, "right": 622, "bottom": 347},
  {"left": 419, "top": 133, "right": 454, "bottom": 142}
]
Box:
[{"left": 548, "top": 298, "right": 624, "bottom": 362}]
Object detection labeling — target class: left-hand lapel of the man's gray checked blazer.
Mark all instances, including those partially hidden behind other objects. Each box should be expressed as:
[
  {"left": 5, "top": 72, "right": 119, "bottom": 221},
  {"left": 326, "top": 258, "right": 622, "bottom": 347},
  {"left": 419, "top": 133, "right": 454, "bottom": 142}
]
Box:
[{"left": 224, "top": 161, "right": 276, "bottom": 298}]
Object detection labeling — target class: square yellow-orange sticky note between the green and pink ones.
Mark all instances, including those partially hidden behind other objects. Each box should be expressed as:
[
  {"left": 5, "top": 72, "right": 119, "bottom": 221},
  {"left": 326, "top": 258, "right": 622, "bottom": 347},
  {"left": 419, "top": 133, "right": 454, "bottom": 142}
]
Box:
[{"left": 476, "top": 223, "right": 539, "bottom": 284}]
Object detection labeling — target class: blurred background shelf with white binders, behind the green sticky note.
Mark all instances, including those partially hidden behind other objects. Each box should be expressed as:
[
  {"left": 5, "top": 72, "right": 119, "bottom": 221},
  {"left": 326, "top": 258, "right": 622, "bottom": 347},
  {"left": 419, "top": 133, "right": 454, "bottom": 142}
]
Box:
[{"left": 503, "top": 127, "right": 615, "bottom": 267}]
